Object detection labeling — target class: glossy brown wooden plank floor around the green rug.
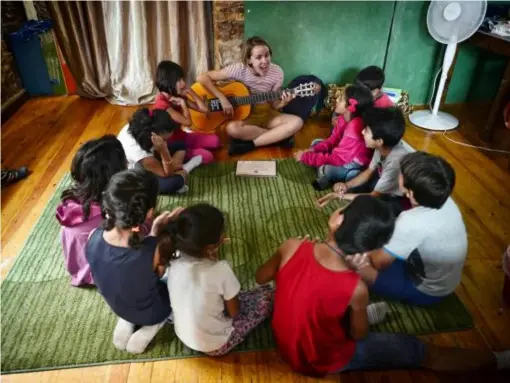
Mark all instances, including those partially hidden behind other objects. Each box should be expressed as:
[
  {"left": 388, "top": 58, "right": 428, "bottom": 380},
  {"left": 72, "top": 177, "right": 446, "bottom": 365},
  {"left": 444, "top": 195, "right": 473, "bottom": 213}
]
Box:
[{"left": 1, "top": 97, "right": 510, "bottom": 383}]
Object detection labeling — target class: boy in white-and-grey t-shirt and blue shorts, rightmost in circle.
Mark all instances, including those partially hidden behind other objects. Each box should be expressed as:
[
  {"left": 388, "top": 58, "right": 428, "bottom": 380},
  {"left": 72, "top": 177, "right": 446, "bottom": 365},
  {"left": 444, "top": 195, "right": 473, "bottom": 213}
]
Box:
[{"left": 344, "top": 152, "right": 467, "bottom": 305}]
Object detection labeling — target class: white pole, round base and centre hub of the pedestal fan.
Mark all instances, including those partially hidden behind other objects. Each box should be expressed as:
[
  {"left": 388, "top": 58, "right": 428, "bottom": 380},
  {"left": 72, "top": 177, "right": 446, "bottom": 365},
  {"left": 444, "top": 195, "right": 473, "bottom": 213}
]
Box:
[{"left": 409, "top": 3, "right": 460, "bottom": 131}]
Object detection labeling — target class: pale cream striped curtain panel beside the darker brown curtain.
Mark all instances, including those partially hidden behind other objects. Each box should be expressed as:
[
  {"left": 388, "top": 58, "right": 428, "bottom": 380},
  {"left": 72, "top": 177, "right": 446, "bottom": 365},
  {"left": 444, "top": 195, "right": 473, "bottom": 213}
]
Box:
[{"left": 102, "top": 0, "right": 209, "bottom": 105}]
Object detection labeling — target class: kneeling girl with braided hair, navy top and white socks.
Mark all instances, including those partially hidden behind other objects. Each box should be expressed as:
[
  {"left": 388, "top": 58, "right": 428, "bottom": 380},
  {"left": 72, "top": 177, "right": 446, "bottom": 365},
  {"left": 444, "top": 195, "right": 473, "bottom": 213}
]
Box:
[{"left": 86, "top": 169, "right": 182, "bottom": 353}]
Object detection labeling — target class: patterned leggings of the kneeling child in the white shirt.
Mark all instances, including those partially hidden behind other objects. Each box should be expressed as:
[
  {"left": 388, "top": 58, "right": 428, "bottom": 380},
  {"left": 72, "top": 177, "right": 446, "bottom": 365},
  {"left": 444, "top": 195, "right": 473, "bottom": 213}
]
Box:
[{"left": 207, "top": 285, "right": 273, "bottom": 356}]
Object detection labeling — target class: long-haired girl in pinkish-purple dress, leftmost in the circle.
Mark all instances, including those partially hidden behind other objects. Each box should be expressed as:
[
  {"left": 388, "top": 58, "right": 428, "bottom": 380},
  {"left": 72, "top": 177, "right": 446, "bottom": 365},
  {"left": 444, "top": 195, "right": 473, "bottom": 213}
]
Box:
[{"left": 56, "top": 135, "right": 126, "bottom": 286}]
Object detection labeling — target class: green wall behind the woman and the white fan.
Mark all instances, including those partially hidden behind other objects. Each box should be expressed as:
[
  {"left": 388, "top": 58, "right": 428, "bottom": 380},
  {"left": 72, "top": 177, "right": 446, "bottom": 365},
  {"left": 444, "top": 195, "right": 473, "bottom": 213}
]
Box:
[{"left": 245, "top": 1, "right": 506, "bottom": 104}]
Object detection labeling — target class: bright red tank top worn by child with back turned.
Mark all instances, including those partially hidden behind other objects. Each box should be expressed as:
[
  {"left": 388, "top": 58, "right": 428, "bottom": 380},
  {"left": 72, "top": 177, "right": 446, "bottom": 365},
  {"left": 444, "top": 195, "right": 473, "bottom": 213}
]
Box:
[{"left": 272, "top": 241, "right": 360, "bottom": 375}]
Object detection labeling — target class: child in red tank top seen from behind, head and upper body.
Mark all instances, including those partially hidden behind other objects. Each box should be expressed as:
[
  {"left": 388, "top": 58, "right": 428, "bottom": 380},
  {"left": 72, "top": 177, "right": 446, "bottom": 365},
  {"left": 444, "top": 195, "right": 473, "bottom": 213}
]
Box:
[{"left": 257, "top": 196, "right": 394, "bottom": 376}]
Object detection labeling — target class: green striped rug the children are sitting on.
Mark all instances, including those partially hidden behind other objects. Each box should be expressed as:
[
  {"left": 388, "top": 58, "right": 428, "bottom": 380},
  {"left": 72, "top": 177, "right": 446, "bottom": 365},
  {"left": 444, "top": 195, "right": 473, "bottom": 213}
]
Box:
[{"left": 1, "top": 160, "right": 473, "bottom": 373}]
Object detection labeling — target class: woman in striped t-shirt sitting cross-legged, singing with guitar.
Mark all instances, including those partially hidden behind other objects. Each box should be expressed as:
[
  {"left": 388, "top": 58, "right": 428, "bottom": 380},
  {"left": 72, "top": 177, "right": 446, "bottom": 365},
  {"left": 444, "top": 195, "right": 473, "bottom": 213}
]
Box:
[{"left": 197, "top": 36, "right": 303, "bottom": 155}]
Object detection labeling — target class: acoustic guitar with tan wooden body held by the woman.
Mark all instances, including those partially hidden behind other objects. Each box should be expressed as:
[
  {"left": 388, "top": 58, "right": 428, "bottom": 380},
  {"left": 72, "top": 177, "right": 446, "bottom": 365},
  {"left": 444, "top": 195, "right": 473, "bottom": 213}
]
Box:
[{"left": 190, "top": 81, "right": 320, "bottom": 132}]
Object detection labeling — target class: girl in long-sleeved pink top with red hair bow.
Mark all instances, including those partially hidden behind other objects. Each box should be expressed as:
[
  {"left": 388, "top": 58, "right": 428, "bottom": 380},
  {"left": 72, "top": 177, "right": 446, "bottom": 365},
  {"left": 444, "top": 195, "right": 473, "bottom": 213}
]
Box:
[{"left": 294, "top": 85, "right": 373, "bottom": 190}]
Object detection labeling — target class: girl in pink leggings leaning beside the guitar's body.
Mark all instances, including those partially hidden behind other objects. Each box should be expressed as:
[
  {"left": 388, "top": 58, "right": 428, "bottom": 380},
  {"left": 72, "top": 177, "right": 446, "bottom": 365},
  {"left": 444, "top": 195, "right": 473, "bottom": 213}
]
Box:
[{"left": 154, "top": 61, "right": 220, "bottom": 164}]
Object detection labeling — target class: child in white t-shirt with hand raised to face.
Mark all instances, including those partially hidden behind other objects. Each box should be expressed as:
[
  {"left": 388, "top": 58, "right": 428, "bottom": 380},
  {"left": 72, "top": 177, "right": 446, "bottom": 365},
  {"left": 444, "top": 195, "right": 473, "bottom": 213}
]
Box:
[{"left": 117, "top": 108, "right": 202, "bottom": 194}]
